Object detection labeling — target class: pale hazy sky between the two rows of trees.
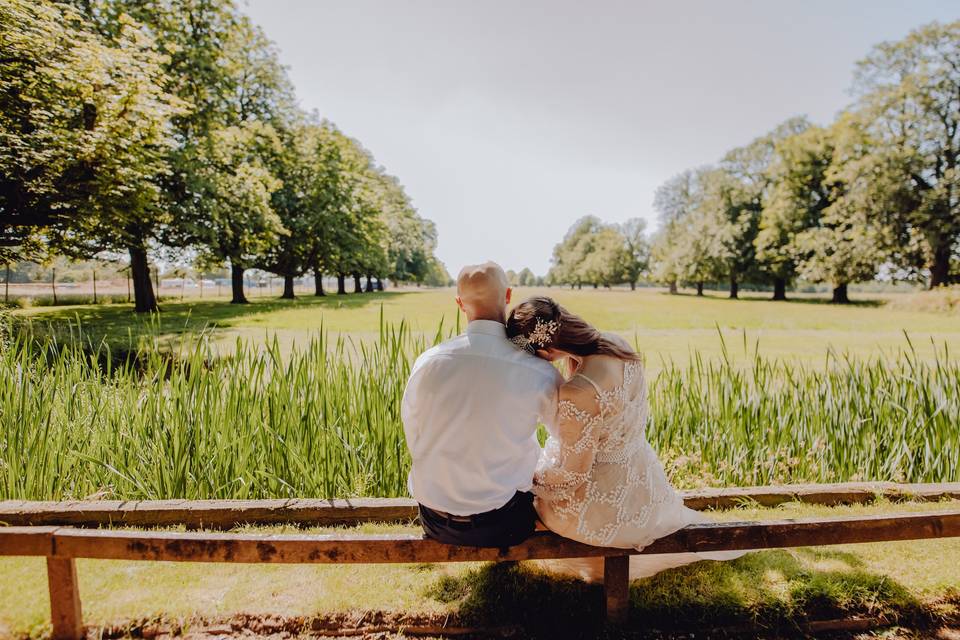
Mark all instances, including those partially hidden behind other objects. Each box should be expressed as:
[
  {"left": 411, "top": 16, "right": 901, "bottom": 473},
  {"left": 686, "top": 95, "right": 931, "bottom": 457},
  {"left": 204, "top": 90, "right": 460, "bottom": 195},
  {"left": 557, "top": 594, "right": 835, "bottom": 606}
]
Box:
[{"left": 245, "top": 0, "right": 960, "bottom": 274}]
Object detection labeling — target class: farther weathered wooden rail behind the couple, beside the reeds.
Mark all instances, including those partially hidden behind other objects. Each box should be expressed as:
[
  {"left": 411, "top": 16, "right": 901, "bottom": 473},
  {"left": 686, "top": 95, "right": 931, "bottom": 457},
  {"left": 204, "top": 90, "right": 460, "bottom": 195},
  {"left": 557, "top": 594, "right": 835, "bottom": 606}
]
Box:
[{"left": 0, "top": 482, "right": 960, "bottom": 529}]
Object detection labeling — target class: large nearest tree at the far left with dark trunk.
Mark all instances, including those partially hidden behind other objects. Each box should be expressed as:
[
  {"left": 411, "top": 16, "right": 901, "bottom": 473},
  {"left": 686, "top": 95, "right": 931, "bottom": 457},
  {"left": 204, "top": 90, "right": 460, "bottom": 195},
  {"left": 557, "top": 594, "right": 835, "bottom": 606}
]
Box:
[{"left": 0, "top": 0, "right": 185, "bottom": 311}]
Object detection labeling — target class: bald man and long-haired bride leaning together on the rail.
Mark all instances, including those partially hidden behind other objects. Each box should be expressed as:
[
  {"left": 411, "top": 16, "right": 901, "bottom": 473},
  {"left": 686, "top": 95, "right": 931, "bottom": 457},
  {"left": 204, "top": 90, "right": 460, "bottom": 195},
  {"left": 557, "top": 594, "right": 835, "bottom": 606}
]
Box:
[{"left": 402, "top": 262, "right": 740, "bottom": 580}]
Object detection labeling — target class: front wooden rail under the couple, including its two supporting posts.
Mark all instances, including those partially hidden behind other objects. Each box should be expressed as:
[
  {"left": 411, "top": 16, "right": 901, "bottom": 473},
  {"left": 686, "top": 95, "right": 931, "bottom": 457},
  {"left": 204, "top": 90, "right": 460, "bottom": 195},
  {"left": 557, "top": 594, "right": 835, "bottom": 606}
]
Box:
[{"left": 0, "top": 510, "right": 960, "bottom": 640}]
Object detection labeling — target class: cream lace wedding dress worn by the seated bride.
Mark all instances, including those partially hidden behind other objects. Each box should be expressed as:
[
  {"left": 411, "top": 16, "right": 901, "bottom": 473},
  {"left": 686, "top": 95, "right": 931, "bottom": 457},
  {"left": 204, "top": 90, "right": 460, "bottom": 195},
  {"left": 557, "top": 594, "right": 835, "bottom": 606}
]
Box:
[{"left": 533, "top": 358, "right": 742, "bottom": 581}]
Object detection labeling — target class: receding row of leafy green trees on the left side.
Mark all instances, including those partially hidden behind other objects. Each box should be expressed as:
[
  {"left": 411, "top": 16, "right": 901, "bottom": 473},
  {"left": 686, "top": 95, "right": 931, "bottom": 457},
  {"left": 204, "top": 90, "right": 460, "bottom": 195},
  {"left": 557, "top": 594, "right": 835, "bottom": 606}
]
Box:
[{"left": 0, "top": 0, "right": 445, "bottom": 311}]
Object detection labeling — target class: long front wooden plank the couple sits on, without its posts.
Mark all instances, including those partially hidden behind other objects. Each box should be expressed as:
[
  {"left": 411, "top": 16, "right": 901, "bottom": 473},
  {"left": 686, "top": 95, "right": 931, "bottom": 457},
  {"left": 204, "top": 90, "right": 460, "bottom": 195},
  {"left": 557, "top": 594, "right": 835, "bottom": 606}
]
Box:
[{"left": 53, "top": 510, "right": 960, "bottom": 564}]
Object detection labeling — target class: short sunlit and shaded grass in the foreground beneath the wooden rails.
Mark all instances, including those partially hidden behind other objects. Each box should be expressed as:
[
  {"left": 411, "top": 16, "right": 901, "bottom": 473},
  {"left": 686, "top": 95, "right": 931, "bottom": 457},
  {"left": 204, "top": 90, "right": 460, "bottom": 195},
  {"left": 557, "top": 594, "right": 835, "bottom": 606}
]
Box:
[{"left": 0, "top": 501, "right": 960, "bottom": 637}]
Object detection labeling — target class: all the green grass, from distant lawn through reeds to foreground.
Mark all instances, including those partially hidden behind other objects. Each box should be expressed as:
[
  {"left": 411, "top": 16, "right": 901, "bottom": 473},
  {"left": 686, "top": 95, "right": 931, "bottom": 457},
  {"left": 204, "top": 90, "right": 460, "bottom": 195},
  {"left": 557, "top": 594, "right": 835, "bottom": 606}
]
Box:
[{"left": 0, "top": 289, "right": 960, "bottom": 637}]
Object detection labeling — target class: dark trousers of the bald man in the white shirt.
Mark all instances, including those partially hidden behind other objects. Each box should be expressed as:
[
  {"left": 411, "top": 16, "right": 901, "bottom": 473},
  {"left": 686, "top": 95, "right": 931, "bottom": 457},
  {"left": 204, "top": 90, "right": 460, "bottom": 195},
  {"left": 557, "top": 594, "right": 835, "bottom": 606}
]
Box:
[{"left": 420, "top": 491, "right": 537, "bottom": 549}]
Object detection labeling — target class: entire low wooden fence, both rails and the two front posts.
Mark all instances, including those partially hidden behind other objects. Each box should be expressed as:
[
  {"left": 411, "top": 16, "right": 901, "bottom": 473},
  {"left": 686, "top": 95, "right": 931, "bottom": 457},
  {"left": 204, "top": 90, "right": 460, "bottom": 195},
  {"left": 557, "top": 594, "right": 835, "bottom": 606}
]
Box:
[{"left": 0, "top": 484, "right": 960, "bottom": 640}]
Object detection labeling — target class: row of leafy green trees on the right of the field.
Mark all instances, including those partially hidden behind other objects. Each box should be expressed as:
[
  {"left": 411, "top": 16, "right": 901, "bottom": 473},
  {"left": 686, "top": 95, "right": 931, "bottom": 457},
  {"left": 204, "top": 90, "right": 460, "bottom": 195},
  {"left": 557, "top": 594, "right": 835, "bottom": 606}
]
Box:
[{"left": 651, "top": 22, "right": 960, "bottom": 302}]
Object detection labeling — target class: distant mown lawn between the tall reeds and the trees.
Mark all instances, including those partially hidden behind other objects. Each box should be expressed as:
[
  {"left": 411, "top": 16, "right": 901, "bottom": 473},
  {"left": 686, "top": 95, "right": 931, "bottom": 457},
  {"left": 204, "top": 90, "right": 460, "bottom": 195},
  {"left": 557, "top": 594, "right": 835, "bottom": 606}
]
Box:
[{"left": 14, "top": 288, "right": 960, "bottom": 368}]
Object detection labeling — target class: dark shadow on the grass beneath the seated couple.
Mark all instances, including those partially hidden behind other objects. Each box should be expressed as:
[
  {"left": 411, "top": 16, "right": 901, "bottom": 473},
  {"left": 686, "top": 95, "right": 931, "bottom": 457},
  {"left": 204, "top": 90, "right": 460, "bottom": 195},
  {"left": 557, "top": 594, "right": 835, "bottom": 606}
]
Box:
[{"left": 424, "top": 549, "right": 935, "bottom": 638}]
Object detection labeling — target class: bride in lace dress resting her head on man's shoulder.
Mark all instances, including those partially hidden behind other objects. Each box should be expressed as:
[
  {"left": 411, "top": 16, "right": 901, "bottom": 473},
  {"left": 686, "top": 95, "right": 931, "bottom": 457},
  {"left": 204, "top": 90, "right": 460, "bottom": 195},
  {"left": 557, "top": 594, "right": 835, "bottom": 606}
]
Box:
[{"left": 507, "top": 297, "right": 742, "bottom": 581}]
